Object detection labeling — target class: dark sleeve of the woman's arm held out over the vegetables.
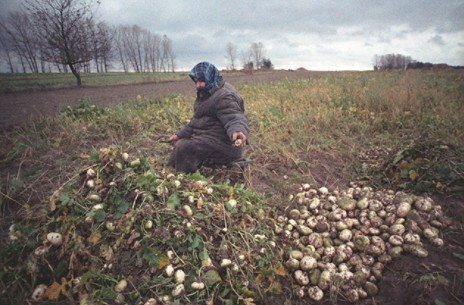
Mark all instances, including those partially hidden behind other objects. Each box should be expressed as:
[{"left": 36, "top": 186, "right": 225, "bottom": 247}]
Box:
[{"left": 216, "top": 94, "right": 250, "bottom": 138}]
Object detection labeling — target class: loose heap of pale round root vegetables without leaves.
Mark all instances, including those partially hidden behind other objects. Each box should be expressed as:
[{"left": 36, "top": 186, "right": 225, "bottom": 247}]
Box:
[{"left": 275, "top": 184, "right": 450, "bottom": 302}]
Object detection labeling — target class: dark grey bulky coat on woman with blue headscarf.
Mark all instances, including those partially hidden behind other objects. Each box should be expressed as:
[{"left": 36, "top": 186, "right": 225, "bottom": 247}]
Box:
[{"left": 168, "top": 81, "right": 250, "bottom": 172}]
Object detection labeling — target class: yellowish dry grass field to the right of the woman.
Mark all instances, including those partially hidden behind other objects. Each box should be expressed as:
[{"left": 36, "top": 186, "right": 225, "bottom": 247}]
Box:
[{"left": 241, "top": 71, "right": 464, "bottom": 191}]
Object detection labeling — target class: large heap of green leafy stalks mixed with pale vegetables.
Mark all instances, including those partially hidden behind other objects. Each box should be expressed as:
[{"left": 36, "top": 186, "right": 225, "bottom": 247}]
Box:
[{"left": 24, "top": 146, "right": 276, "bottom": 304}]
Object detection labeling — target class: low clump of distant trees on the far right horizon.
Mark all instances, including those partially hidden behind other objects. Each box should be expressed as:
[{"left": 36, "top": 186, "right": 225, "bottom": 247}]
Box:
[{"left": 373, "top": 54, "right": 464, "bottom": 70}]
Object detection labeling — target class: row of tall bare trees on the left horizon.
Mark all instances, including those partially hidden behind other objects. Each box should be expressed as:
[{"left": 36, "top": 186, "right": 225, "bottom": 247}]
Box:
[{"left": 0, "top": 0, "right": 175, "bottom": 85}]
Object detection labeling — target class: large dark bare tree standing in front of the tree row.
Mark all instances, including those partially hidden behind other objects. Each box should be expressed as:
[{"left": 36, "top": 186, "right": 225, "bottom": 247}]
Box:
[{"left": 25, "top": 0, "right": 99, "bottom": 86}]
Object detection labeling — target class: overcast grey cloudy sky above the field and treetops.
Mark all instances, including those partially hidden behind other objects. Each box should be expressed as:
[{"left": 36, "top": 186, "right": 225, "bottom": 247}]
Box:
[{"left": 0, "top": 0, "right": 464, "bottom": 70}]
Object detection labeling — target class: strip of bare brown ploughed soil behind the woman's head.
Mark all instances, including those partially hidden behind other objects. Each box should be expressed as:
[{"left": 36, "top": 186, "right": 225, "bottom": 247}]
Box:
[{"left": 0, "top": 71, "right": 317, "bottom": 130}]
